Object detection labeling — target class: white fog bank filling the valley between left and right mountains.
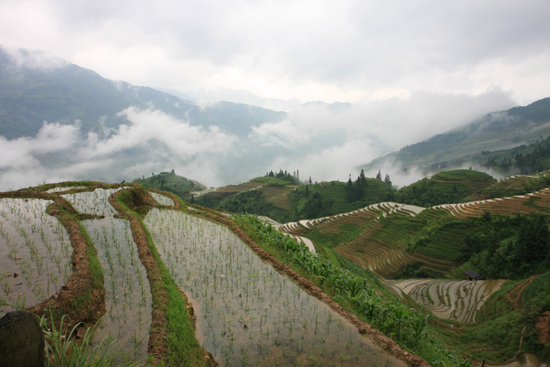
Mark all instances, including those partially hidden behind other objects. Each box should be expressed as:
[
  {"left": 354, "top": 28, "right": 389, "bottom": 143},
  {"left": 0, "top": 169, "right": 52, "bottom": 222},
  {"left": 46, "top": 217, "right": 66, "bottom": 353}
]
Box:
[{"left": 0, "top": 89, "right": 514, "bottom": 191}]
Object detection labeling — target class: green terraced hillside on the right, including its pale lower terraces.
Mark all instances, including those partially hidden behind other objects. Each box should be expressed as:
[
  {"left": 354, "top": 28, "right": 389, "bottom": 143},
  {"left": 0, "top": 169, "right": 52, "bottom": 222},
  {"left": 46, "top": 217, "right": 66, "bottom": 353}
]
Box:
[{"left": 281, "top": 170, "right": 550, "bottom": 363}]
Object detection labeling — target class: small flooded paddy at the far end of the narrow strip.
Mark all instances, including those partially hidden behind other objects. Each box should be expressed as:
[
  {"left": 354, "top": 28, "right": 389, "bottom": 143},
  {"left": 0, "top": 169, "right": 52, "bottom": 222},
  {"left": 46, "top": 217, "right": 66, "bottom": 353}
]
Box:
[{"left": 61, "top": 188, "right": 121, "bottom": 217}]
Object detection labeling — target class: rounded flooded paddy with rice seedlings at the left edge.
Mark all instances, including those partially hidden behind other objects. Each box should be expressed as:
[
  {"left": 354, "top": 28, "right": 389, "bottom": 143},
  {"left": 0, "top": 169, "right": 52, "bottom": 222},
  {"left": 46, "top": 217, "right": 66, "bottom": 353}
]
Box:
[{"left": 0, "top": 198, "right": 72, "bottom": 317}]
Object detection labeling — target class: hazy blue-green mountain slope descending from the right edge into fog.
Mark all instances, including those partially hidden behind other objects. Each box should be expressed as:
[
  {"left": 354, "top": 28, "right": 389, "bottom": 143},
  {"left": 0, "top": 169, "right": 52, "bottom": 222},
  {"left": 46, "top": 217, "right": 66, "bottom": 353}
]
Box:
[{"left": 360, "top": 98, "right": 550, "bottom": 174}]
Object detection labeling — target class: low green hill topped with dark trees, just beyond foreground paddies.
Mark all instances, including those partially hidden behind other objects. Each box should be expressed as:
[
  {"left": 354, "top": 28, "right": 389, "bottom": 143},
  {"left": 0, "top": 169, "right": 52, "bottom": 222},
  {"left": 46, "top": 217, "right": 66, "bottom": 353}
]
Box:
[{"left": 192, "top": 170, "right": 395, "bottom": 222}]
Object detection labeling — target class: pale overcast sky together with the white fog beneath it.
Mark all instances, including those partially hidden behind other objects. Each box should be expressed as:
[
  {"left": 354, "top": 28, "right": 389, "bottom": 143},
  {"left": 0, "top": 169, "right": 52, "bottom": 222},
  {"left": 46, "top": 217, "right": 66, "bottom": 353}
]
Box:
[{"left": 0, "top": 0, "right": 550, "bottom": 189}]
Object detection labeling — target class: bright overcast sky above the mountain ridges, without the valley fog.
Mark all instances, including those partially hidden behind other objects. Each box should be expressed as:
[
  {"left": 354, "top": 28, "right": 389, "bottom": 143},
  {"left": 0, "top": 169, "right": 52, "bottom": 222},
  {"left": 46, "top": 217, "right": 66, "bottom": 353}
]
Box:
[{"left": 0, "top": 0, "right": 550, "bottom": 105}]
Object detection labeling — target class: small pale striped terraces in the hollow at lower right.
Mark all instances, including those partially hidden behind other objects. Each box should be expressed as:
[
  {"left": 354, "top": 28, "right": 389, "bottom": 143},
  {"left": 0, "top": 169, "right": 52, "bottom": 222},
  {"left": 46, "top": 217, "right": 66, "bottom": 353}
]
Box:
[{"left": 385, "top": 279, "right": 505, "bottom": 322}]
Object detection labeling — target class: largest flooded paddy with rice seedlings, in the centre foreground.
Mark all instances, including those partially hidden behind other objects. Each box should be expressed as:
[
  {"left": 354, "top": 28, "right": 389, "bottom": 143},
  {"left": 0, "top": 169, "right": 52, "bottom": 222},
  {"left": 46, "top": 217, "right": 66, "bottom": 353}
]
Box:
[{"left": 145, "top": 209, "right": 403, "bottom": 366}]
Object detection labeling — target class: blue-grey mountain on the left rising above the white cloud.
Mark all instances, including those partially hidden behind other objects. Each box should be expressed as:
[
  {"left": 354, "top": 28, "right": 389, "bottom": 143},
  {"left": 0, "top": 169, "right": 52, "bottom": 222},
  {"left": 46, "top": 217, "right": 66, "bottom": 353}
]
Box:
[{"left": 0, "top": 46, "right": 286, "bottom": 139}]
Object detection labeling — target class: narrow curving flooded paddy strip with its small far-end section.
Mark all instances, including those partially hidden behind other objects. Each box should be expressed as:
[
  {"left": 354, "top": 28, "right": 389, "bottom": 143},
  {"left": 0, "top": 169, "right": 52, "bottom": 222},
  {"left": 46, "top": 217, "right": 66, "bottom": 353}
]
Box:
[{"left": 73, "top": 189, "right": 152, "bottom": 366}]
